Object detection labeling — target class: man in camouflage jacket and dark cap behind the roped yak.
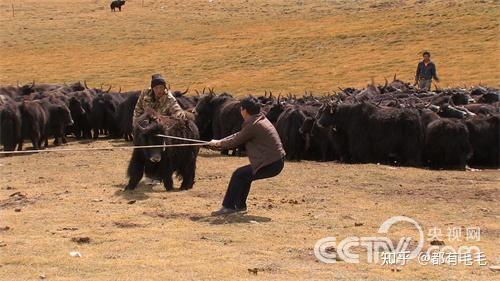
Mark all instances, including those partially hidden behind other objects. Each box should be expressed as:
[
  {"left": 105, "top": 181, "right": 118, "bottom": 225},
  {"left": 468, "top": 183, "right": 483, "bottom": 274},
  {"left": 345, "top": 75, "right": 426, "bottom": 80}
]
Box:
[{"left": 133, "top": 74, "right": 186, "bottom": 125}]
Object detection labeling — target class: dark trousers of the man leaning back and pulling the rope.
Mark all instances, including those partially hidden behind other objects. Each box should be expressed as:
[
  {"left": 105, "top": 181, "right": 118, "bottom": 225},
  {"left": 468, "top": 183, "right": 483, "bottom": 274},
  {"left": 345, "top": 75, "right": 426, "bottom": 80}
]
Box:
[{"left": 222, "top": 159, "right": 284, "bottom": 209}]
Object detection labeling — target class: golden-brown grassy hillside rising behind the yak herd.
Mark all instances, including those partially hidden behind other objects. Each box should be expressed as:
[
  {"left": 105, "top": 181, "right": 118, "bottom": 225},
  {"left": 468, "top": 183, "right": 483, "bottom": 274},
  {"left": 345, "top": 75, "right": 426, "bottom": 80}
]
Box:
[{"left": 0, "top": 0, "right": 500, "bottom": 94}]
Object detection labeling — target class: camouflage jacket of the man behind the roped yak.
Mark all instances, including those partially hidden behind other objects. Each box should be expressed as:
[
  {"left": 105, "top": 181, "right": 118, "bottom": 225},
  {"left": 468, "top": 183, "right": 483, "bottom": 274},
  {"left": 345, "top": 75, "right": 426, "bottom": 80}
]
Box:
[{"left": 134, "top": 88, "right": 186, "bottom": 123}]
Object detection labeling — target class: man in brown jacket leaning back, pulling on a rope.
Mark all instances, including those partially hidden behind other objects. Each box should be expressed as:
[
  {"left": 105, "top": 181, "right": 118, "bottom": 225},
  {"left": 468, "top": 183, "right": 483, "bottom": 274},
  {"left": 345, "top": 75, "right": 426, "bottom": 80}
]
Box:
[{"left": 208, "top": 97, "right": 285, "bottom": 216}]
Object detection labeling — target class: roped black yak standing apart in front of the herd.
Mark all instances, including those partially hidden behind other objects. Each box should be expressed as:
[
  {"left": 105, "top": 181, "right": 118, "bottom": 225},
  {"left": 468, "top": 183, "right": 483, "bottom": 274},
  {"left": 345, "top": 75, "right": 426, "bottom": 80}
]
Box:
[{"left": 125, "top": 111, "right": 200, "bottom": 190}]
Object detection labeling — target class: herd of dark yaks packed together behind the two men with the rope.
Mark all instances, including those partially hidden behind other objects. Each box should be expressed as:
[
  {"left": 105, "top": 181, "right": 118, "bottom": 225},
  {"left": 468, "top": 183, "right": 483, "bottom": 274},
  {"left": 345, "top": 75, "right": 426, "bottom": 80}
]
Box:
[{"left": 0, "top": 77, "right": 500, "bottom": 172}]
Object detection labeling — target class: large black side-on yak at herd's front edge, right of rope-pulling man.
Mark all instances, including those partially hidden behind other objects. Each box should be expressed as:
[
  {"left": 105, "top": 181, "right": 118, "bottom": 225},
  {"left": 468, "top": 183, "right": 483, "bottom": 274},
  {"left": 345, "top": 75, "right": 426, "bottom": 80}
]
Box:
[{"left": 318, "top": 103, "right": 423, "bottom": 166}]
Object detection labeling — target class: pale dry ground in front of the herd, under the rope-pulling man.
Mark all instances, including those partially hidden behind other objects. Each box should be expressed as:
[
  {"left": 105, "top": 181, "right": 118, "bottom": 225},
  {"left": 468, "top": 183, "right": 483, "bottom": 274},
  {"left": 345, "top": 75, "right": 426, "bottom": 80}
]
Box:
[{"left": 0, "top": 140, "right": 500, "bottom": 280}]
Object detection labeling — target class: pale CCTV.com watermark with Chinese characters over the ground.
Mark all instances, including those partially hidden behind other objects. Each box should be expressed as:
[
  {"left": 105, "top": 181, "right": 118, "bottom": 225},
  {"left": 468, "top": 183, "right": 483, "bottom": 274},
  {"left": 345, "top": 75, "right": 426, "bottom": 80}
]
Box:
[{"left": 314, "top": 216, "right": 487, "bottom": 266}]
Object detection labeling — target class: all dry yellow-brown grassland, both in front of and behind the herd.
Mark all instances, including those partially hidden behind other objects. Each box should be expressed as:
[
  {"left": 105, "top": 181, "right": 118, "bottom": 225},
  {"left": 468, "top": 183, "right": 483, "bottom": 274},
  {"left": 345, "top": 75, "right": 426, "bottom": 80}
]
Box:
[{"left": 0, "top": 0, "right": 500, "bottom": 280}]
